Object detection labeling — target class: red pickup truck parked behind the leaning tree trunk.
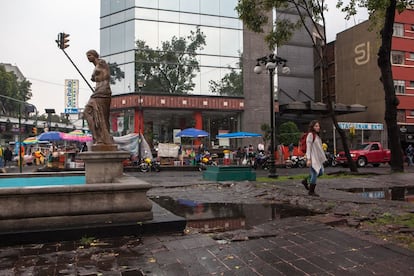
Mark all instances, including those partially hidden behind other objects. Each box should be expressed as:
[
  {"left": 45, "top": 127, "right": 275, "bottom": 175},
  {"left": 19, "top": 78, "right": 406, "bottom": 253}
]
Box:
[{"left": 336, "top": 142, "right": 391, "bottom": 167}]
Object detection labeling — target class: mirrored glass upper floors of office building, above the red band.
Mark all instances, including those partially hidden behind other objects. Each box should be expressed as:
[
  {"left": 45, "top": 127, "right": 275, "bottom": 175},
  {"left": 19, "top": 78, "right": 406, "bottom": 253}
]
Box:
[{"left": 100, "top": 0, "right": 243, "bottom": 95}]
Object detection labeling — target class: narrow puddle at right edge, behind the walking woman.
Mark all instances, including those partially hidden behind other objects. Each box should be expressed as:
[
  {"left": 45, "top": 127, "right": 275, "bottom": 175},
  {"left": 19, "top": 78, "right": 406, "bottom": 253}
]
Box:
[{"left": 343, "top": 187, "right": 414, "bottom": 203}]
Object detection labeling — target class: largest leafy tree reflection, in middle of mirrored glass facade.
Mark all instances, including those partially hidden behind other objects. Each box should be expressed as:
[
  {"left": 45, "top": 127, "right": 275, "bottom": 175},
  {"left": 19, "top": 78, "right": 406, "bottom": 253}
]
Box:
[{"left": 135, "top": 28, "right": 206, "bottom": 94}]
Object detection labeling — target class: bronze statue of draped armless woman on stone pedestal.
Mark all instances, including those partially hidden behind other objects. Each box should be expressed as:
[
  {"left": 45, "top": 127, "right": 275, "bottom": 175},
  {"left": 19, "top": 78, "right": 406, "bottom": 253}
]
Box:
[{"left": 83, "top": 50, "right": 114, "bottom": 145}]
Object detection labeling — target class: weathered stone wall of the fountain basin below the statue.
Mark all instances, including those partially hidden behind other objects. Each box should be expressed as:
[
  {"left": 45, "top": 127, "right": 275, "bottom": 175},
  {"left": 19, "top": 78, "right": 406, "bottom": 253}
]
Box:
[{"left": 0, "top": 176, "right": 153, "bottom": 234}]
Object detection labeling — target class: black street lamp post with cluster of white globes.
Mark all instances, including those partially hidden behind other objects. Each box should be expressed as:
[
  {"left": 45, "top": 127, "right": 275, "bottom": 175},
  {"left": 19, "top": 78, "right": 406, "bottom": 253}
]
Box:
[{"left": 254, "top": 54, "right": 290, "bottom": 178}]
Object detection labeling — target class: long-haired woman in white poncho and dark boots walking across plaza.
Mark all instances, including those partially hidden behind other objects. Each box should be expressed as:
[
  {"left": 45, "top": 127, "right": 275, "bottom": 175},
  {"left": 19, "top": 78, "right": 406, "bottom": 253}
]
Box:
[{"left": 302, "top": 120, "right": 326, "bottom": 196}]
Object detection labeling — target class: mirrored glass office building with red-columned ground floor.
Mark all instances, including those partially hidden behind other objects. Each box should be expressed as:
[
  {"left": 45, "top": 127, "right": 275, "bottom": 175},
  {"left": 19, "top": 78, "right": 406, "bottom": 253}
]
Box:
[{"left": 100, "top": 0, "right": 243, "bottom": 142}]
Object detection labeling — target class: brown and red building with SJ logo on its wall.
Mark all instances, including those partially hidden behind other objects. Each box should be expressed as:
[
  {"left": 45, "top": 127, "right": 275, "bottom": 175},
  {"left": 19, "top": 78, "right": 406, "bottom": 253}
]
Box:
[{"left": 335, "top": 9, "right": 414, "bottom": 147}]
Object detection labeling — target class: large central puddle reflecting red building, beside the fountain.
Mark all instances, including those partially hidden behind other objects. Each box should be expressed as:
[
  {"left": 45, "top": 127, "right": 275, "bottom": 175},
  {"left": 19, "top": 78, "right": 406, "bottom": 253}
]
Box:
[{"left": 151, "top": 196, "right": 315, "bottom": 232}]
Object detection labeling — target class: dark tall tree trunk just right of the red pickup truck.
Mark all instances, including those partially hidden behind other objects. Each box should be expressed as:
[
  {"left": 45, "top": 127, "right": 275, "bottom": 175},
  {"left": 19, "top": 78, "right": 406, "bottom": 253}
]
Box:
[{"left": 337, "top": 0, "right": 404, "bottom": 172}]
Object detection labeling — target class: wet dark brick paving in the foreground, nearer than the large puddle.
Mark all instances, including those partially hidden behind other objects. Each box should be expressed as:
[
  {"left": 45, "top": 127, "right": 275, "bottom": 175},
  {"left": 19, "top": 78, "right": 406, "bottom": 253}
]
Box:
[{"left": 0, "top": 218, "right": 414, "bottom": 276}]
